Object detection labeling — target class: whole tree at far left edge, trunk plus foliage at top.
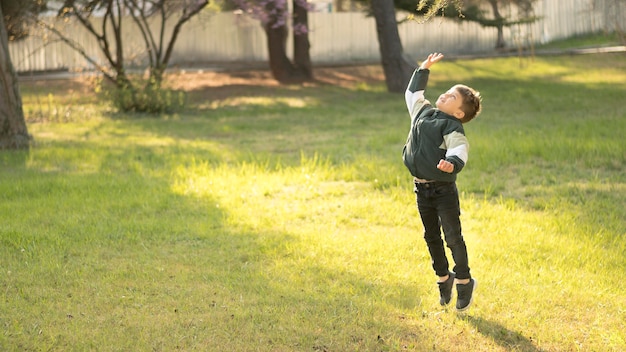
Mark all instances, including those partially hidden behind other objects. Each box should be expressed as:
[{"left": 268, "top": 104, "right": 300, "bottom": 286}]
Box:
[{"left": 0, "top": 0, "right": 45, "bottom": 149}]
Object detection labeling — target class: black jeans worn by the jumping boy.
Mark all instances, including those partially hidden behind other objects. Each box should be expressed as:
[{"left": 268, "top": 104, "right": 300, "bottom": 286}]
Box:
[{"left": 415, "top": 182, "right": 471, "bottom": 279}]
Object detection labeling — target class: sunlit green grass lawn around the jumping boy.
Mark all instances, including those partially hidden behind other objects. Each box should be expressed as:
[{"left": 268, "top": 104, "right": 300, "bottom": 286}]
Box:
[{"left": 0, "top": 54, "right": 626, "bottom": 351}]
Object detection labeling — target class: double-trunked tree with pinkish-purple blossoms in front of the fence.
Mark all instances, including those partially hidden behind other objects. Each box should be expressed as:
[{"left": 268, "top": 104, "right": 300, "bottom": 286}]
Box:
[{"left": 234, "top": 0, "right": 313, "bottom": 83}]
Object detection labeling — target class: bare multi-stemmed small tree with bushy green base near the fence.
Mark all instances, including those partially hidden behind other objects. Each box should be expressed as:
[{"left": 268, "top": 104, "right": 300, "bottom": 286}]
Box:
[{"left": 47, "top": 0, "right": 209, "bottom": 112}]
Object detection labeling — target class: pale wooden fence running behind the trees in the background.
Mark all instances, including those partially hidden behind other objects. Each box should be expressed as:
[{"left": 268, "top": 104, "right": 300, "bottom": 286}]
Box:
[{"left": 9, "top": 0, "right": 626, "bottom": 73}]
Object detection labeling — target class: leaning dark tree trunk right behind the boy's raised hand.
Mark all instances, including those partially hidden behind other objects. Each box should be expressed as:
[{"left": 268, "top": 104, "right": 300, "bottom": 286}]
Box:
[{"left": 372, "top": 0, "right": 415, "bottom": 93}]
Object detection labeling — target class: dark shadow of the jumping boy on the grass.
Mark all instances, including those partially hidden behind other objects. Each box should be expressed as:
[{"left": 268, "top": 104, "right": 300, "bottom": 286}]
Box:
[{"left": 459, "top": 315, "right": 544, "bottom": 352}]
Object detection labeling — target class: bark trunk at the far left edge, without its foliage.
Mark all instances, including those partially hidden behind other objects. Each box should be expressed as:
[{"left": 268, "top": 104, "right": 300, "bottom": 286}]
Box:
[{"left": 0, "top": 4, "right": 31, "bottom": 149}]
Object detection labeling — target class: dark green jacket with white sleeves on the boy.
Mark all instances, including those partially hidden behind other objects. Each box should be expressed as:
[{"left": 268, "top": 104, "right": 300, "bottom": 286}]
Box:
[{"left": 402, "top": 69, "right": 469, "bottom": 182}]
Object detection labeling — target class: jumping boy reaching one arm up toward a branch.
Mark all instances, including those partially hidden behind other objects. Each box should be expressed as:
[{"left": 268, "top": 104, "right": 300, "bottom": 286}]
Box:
[{"left": 402, "top": 53, "right": 481, "bottom": 311}]
